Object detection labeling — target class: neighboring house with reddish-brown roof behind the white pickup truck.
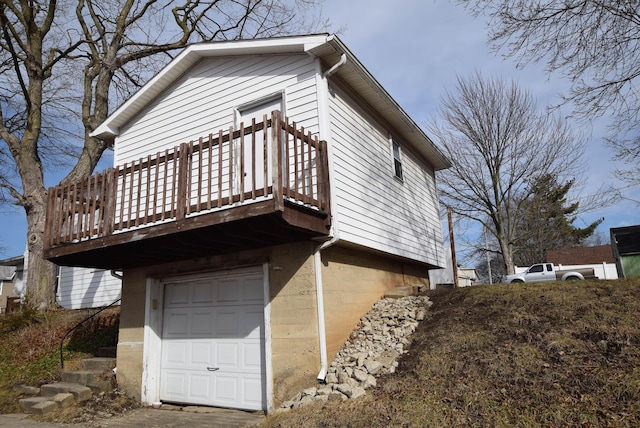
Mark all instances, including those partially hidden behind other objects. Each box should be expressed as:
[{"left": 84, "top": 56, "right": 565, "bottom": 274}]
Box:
[{"left": 546, "top": 244, "right": 618, "bottom": 279}]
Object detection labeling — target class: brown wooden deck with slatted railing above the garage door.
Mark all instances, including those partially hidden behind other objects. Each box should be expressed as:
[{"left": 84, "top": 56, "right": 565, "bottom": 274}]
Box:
[{"left": 45, "top": 111, "right": 330, "bottom": 269}]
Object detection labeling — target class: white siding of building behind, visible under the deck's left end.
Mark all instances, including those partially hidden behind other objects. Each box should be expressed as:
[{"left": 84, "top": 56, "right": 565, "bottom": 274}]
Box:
[{"left": 56, "top": 266, "right": 122, "bottom": 309}]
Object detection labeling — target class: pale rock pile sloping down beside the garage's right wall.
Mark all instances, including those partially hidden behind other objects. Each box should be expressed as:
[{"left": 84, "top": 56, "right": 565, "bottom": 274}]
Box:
[{"left": 281, "top": 296, "right": 431, "bottom": 409}]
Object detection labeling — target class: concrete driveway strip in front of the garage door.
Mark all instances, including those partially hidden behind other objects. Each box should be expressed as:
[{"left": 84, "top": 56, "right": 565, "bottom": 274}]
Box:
[{"left": 0, "top": 406, "right": 265, "bottom": 428}]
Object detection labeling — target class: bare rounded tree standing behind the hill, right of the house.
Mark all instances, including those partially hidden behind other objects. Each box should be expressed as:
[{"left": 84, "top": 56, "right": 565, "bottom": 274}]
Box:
[{"left": 430, "top": 73, "right": 584, "bottom": 274}]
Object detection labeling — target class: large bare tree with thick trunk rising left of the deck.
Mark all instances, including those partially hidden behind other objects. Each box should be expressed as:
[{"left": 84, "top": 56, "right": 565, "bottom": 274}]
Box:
[{"left": 0, "top": 0, "right": 324, "bottom": 309}]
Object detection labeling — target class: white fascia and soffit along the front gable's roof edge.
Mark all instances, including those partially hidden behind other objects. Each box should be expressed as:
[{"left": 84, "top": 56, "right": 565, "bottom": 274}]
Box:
[{"left": 91, "top": 34, "right": 329, "bottom": 141}]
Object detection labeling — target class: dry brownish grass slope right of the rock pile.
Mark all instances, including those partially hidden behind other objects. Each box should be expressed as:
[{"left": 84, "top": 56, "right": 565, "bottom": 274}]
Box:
[{"left": 264, "top": 280, "right": 640, "bottom": 427}]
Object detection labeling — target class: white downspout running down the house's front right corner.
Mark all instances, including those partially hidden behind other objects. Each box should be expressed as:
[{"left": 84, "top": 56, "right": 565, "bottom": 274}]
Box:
[{"left": 313, "top": 49, "right": 347, "bottom": 382}]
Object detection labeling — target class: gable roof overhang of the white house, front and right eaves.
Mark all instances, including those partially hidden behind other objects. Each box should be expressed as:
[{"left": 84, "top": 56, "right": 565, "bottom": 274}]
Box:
[{"left": 91, "top": 34, "right": 451, "bottom": 170}]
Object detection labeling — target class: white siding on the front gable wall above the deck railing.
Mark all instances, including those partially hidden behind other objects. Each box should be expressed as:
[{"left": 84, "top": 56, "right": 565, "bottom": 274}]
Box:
[{"left": 114, "top": 55, "right": 318, "bottom": 165}]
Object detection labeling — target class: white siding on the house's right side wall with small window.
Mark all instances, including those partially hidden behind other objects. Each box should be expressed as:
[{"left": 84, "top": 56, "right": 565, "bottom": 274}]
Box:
[{"left": 330, "top": 83, "right": 444, "bottom": 266}]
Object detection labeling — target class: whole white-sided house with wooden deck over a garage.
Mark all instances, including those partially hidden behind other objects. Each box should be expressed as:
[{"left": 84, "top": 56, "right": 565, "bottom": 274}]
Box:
[{"left": 45, "top": 35, "right": 450, "bottom": 411}]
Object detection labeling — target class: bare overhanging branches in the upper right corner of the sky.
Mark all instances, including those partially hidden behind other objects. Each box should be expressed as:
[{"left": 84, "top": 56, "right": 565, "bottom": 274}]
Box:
[{"left": 460, "top": 0, "right": 640, "bottom": 191}]
